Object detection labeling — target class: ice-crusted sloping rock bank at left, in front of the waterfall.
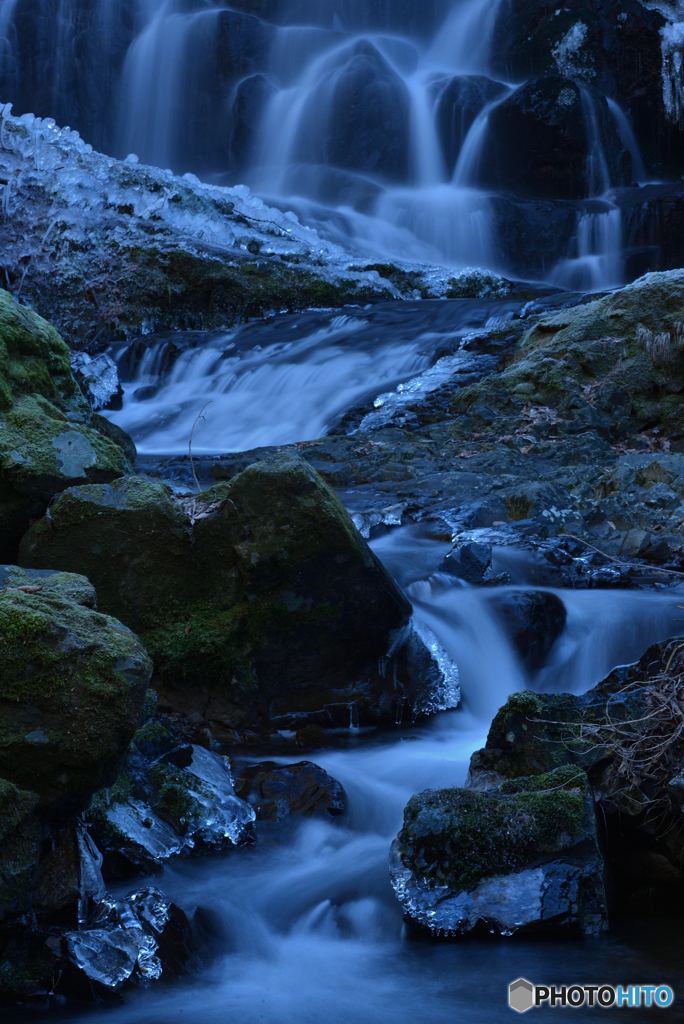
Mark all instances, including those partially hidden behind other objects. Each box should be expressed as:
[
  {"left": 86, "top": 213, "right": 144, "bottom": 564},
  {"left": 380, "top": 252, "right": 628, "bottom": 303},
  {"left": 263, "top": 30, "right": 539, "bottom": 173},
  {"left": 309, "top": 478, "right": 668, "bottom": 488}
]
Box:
[{"left": 0, "top": 108, "right": 395, "bottom": 354}]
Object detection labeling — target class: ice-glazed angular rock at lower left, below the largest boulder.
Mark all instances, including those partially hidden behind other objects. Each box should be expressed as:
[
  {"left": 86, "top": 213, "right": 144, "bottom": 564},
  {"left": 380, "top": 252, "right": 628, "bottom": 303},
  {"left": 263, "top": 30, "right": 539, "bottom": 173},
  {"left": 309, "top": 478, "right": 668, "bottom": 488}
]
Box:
[{"left": 87, "top": 741, "right": 255, "bottom": 879}]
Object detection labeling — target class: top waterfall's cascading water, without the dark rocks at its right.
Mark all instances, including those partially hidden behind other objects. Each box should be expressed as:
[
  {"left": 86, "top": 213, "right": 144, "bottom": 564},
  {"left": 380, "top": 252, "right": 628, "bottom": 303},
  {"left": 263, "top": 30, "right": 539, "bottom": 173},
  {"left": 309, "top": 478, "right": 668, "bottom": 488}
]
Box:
[{"left": 0, "top": 0, "right": 646, "bottom": 288}]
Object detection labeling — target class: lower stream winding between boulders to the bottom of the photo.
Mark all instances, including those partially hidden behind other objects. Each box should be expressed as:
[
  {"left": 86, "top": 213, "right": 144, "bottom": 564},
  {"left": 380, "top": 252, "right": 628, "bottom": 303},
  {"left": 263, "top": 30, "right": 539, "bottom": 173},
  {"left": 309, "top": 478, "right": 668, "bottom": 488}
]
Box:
[{"left": 24, "top": 527, "right": 684, "bottom": 1024}]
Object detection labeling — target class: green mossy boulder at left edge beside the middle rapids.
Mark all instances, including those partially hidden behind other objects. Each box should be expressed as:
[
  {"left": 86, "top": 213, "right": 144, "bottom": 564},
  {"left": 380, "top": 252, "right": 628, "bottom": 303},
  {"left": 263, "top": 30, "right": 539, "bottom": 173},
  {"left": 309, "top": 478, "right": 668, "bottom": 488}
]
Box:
[{"left": 0, "top": 291, "right": 130, "bottom": 561}]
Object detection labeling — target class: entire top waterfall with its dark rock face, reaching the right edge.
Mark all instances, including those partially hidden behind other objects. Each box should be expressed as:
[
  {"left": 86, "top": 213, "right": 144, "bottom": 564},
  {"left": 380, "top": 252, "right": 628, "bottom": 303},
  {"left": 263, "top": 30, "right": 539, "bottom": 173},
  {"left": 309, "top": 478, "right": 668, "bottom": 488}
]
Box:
[{"left": 0, "top": 0, "right": 682, "bottom": 288}]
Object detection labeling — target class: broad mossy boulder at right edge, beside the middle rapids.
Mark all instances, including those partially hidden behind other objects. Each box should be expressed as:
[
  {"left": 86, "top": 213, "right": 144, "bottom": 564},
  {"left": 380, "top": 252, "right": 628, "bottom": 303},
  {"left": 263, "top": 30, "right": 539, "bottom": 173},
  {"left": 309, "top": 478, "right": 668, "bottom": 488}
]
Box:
[{"left": 454, "top": 270, "right": 684, "bottom": 441}]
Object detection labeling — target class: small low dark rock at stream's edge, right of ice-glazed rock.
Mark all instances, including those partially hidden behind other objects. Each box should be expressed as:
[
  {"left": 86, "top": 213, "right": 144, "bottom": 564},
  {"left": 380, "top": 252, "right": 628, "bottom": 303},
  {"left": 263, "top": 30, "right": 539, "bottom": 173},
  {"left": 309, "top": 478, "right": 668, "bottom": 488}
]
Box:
[{"left": 236, "top": 761, "right": 345, "bottom": 821}]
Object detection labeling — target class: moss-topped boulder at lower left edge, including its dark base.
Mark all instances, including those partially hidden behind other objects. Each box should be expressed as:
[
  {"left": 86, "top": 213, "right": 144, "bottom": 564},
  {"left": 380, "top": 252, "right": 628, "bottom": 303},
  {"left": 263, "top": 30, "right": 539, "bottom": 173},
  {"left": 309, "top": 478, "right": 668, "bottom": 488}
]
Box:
[{"left": 0, "top": 565, "right": 156, "bottom": 1000}]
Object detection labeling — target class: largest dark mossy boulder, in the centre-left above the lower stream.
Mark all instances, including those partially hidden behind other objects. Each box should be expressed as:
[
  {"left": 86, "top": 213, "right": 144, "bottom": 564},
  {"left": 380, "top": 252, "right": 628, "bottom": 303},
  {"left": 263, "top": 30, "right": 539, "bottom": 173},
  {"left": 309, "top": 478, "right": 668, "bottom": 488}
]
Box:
[{"left": 20, "top": 453, "right": 411, "bottom": 728}]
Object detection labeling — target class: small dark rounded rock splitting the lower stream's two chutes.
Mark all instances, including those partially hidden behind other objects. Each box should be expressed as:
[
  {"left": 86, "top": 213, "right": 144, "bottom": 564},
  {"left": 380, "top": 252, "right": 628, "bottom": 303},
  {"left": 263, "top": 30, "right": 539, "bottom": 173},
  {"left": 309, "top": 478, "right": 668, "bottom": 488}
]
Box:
[{"left": 489, "top": 590, "right": 566, "bottom": 672}]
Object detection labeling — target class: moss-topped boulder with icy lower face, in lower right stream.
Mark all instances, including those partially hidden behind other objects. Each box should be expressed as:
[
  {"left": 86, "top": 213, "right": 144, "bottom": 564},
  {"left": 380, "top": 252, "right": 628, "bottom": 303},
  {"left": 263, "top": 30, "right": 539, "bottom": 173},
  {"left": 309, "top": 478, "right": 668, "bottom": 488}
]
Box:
[{"left": 391, "top": 766, "right": 606, "bottom": 936}]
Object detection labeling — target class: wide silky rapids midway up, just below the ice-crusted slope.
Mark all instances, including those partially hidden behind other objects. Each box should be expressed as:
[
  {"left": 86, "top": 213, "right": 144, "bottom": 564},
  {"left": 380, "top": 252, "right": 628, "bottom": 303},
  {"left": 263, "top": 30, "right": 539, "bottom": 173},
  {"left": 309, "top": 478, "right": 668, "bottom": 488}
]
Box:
[{"left": 108, "top": 300, "right": 516, "bottom": 455}]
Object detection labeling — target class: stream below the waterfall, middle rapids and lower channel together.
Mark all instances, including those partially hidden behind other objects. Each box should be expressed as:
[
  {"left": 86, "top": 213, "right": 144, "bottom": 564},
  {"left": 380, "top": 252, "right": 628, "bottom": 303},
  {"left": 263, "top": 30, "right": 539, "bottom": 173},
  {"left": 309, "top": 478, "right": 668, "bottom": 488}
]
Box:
[{"left": 26, "top": 302, "right": 684, "bottom": 1024}]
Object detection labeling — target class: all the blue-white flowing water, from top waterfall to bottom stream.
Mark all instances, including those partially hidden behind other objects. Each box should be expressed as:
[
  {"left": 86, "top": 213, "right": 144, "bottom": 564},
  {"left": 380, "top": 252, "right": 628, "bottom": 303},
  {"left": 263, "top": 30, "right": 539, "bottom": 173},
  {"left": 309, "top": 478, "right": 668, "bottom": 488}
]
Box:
[{"left": 0, "top": 0, "right": 684, "bottom": 1024}]
